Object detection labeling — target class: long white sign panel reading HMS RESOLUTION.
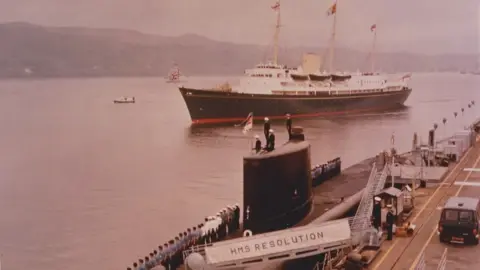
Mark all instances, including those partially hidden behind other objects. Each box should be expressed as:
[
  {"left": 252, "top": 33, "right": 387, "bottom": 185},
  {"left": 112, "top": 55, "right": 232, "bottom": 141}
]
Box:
[{"left": 205, "top": 220, "right": 351, "bottom": 264}]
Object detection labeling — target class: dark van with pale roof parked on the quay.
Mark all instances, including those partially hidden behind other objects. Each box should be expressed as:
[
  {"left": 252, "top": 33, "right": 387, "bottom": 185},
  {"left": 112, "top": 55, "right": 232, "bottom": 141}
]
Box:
[{"left": 437, "top": 197, "right": 480, "bottom": 245}]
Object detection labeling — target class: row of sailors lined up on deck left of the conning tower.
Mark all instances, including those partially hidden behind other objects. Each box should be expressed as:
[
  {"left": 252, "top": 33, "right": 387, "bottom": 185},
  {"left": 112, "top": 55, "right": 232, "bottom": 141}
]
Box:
[{"left": 127, "top": 204, "right": 240, "bottom": 270}]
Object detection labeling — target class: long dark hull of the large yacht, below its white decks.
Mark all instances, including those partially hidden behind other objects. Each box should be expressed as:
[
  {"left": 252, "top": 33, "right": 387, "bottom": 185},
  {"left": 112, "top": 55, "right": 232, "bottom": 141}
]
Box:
[{"left": 179, "top": 87, "right": 412, "bottom": 124}]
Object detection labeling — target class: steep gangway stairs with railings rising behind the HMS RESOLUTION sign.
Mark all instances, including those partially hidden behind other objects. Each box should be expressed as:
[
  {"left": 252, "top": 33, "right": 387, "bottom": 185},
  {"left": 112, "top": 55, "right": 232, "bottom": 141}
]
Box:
[{"left": 352, "top": 163, "right": 388, "bottom": 232}]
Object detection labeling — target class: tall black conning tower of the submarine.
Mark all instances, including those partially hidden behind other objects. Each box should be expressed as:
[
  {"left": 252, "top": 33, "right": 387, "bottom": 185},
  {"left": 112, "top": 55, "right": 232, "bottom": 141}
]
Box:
[{"left": 243, "top": 127, "right": 313, "bottom": 234}]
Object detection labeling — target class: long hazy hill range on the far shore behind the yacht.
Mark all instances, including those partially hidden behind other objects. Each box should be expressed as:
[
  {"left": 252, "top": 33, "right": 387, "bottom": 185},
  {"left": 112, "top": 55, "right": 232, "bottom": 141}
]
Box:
[{"left": 0, "top": 23, "right": 476, "bottom": 77}]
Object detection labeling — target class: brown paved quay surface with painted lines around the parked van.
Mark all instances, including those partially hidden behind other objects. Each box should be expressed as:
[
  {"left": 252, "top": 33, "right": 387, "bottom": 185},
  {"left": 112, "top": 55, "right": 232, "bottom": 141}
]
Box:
[{"left": 369, "top": 138, "right": 480, "bottom": 270}]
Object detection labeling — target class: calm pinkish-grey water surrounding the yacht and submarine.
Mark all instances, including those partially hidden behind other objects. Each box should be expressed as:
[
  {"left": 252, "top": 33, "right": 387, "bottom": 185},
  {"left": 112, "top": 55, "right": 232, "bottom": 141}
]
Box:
[{"left": 0, "top": 74, "right": 480, "bottom": 270}]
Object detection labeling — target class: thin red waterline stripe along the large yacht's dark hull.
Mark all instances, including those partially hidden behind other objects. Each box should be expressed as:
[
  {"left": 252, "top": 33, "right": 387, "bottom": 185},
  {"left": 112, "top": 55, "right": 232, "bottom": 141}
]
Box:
[{"left": 192, "top": 106, "right": 402, "bottom": 124}]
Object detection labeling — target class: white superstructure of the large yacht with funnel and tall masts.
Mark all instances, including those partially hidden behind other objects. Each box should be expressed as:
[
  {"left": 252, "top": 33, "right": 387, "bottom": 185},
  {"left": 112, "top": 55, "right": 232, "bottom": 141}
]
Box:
[{"left": 228, "top": 1, "right": 411, "bottom": 95}]
